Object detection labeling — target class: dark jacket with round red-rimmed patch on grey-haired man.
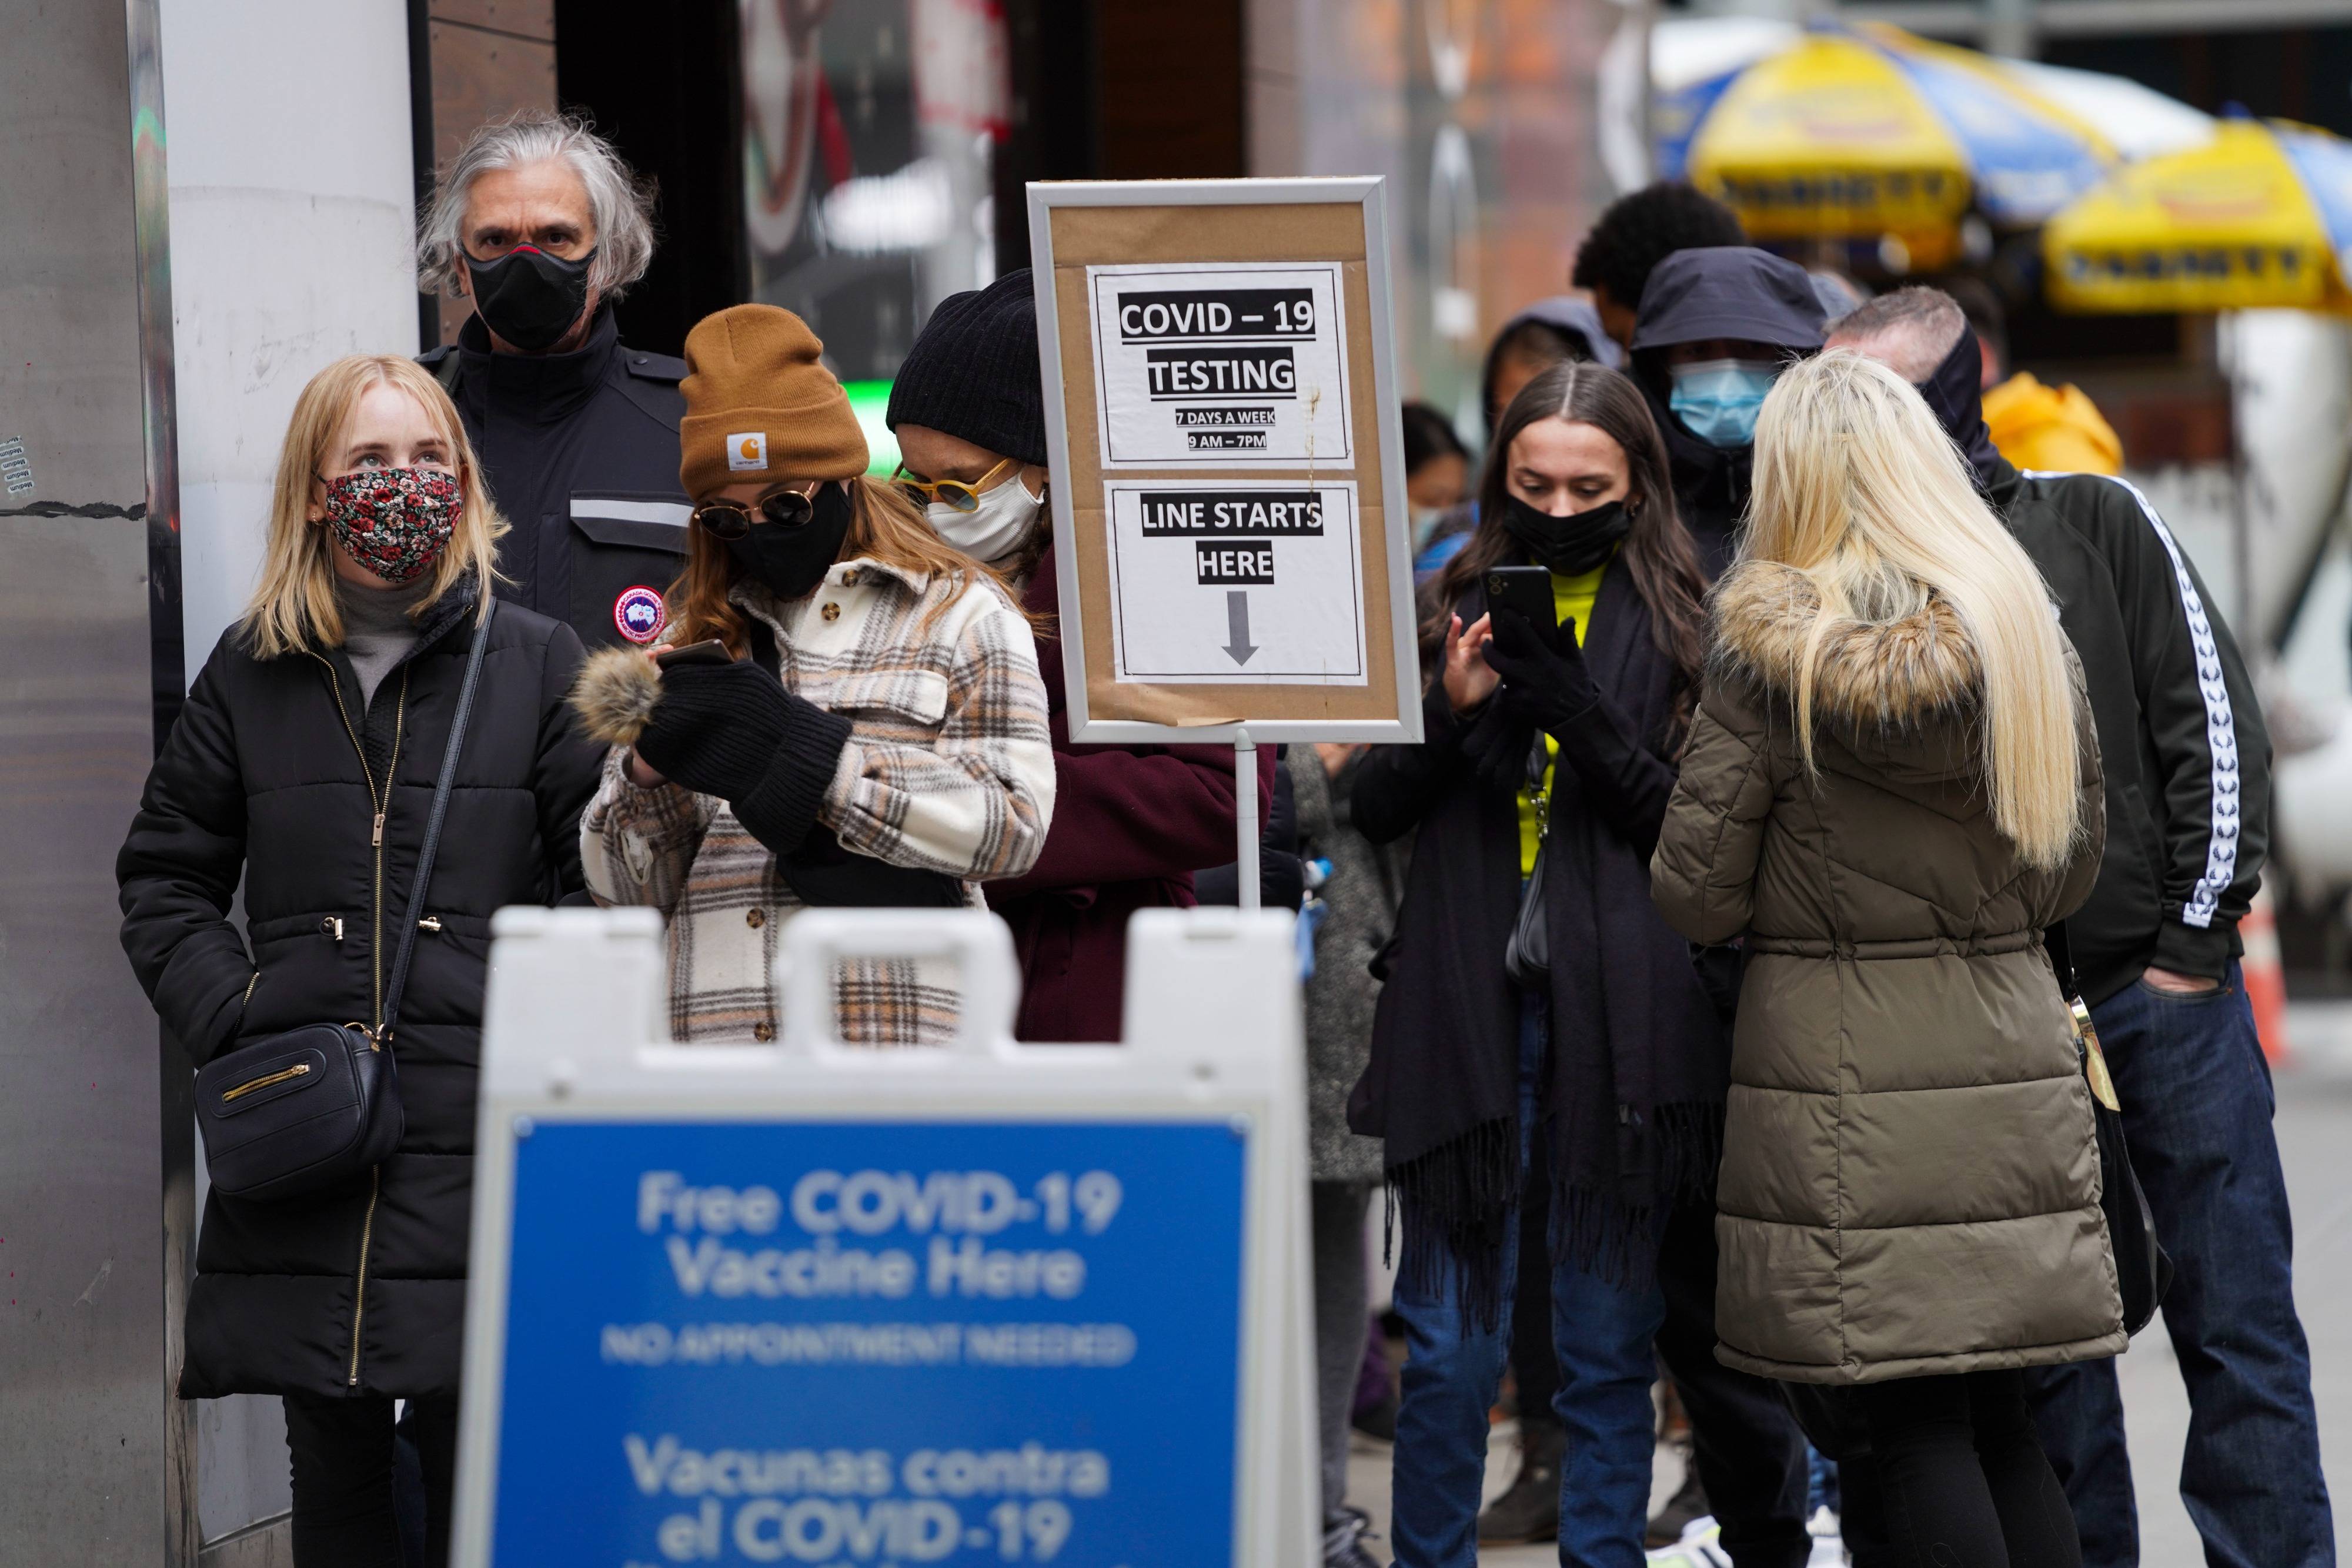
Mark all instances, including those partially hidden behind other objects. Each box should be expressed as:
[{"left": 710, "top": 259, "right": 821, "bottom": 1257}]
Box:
[{"left": 423, "top": 306, "right": 689, "bottom": 649}]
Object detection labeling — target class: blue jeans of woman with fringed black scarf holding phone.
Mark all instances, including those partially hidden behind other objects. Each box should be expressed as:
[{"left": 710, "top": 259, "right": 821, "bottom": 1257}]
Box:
[{"left": 1390, "top": 1004, "right": 1665, "bottom": 1568}]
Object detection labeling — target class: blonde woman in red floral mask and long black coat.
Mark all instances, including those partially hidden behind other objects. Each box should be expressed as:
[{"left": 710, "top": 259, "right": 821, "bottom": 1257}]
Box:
[{"left": 115, "top": 355, "right": 600, "bottom": 1568}]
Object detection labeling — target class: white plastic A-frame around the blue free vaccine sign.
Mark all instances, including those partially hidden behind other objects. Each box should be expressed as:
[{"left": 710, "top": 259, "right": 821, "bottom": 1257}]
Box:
[{"left": 452, "top": 907, "right": 1319, "bottom": 1568}]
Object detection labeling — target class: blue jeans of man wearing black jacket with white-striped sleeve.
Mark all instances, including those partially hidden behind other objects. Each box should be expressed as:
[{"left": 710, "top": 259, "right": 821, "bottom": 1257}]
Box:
[{"left": 2030, "top": 964, "right": 2336, "bottom": 1568}]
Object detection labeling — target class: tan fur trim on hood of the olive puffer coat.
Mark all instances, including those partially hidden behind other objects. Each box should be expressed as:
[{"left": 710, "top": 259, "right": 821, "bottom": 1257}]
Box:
[{"left": 1710, "top": 562, "right": 1985, "bottom": 736}]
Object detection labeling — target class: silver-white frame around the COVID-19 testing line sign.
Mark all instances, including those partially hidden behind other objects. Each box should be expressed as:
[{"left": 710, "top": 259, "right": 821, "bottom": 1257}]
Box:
[{"left": 1028, "top": 176, "right": 1423, "bottom": 745}]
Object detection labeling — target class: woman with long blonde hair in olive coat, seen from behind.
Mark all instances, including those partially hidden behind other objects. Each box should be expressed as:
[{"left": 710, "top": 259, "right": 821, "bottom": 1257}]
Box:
[{"left": 1651, "top": 350, "right": 2126, "bottom": 1568}]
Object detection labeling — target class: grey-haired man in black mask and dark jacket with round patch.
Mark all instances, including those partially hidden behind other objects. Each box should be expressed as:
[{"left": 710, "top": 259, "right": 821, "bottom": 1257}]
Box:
[{"left": 416, "top": 111, "right": 687, "bottom": 649}]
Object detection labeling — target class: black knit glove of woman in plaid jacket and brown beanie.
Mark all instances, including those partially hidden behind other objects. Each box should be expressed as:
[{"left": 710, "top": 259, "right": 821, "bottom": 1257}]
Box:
[{"left": 637, "top": 661, "right": 849, "bottom": 853}]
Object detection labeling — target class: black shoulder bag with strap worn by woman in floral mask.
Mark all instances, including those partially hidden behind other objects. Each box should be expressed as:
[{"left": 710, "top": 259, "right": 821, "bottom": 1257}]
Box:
[{"left": 195, "top": 602, "right": 496, "bottom": 1201}]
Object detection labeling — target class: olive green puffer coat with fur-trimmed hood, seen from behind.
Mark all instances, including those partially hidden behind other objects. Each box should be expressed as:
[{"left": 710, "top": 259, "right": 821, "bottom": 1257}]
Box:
[{"left": 1651, "top": 562, "right": 2126, "bottom": 1382}]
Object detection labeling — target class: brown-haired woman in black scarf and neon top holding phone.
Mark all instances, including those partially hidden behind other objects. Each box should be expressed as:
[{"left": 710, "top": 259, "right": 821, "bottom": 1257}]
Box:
[{"left": 1350, "top": 362, "right": 1804, "bottom": 1568}]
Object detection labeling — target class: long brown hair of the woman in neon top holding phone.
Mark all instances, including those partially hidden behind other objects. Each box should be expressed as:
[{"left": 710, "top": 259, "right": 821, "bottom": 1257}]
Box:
[{"left": 1421, "top": 360, "right": 1708, "bottom": 724}]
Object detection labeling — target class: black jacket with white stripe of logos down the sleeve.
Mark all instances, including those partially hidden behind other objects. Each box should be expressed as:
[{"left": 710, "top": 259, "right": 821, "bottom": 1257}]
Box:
[{"left": 1983, "top": 456, "right": 2270, "bottom": 1001}]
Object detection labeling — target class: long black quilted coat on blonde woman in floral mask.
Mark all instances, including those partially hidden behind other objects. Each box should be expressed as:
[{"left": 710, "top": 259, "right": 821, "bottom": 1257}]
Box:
[{"left": 115, "top": 587, "right": 604, "bottom": 1399}]
